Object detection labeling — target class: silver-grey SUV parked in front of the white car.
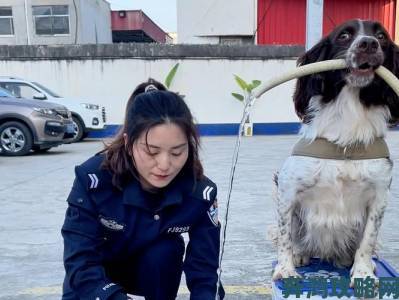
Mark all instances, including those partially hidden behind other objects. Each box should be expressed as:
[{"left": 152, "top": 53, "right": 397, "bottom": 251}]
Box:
[{"left": 0, "top": 89, "right": 74, "bottom": 156}]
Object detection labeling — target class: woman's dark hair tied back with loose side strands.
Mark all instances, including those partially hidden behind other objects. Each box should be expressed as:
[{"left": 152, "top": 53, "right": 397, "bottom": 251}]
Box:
[{"left": 101, "top": 79, "right": 203, "bottom": 189}]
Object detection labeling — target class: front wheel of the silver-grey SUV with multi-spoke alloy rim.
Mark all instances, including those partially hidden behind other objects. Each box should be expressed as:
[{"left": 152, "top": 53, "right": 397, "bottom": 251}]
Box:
[{"left": 0, "top": 122, "right": 33, "bottom": 156}]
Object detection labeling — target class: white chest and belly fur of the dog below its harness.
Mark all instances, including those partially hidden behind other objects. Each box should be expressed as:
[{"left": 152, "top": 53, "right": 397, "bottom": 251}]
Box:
[{"left": 279, "top": 156, "right": 392, "bottom": 265}]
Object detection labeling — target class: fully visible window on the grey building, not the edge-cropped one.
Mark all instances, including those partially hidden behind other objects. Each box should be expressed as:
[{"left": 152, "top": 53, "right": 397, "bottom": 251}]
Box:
[{"left": 32, "top": 5, "right": 69, "bottom": 35}]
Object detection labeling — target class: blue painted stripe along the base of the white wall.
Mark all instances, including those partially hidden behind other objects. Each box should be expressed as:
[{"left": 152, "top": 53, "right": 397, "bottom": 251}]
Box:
[{"left": 89, "top": 122, "right": 300, "bottom": 138}]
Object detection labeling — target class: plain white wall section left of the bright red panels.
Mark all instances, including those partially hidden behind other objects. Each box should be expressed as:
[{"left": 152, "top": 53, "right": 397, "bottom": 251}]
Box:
[{"left": 177, "top": 0, "right": 256, "bottom": 44}]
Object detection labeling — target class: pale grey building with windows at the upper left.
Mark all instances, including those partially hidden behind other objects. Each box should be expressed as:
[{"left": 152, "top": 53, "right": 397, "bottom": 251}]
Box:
[{"left": 0, "top": 0, "right": 112, "bottom": 45}]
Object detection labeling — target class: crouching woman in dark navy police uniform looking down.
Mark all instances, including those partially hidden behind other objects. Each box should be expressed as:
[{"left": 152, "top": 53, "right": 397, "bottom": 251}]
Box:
[{"left": 62, "top": 79, "right": 224, "bottom": 300}]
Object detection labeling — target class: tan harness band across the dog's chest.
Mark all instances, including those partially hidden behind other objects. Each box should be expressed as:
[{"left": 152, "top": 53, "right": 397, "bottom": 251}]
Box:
[{"left": 291, "top": 138, "right": 389, "bottom": 160}]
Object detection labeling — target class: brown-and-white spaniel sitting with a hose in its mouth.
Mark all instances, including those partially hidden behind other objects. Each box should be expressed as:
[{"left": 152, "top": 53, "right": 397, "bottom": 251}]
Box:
[{"left": 273, "top": 20, "right": 399, "bottom": 285}]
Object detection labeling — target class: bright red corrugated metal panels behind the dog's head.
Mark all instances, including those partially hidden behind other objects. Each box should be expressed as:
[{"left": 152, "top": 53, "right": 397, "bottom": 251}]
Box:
[{"left": 257, "top": 0, "right": 396, "bottom": 45}]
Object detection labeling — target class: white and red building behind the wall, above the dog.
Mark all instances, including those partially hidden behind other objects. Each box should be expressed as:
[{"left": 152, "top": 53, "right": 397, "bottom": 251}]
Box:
[{"left": 177, "top": 0, "right": 399, "bottom": 45}]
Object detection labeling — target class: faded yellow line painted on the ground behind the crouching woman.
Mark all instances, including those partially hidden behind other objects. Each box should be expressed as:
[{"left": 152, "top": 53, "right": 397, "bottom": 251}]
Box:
[{"left": 18, "top": 285, "right": 271, "bottom": 296}]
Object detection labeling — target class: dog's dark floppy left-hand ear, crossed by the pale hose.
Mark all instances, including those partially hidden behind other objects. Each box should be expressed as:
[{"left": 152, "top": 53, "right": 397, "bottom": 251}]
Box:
[{"left": 294, "top": 37, "right": 330, "bottom": 123}]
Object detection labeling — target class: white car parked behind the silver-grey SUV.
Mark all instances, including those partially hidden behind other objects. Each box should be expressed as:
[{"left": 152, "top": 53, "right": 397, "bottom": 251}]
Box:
[{"left": 0, "top": 76, "right": 106, "bottom": 142}]
